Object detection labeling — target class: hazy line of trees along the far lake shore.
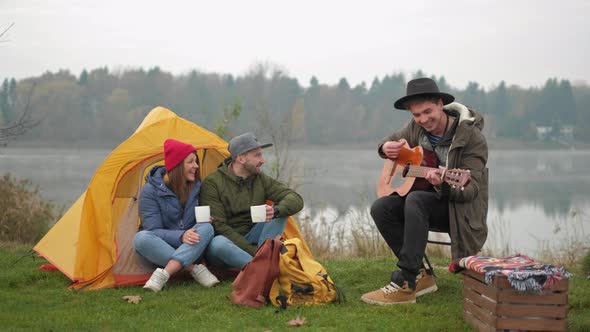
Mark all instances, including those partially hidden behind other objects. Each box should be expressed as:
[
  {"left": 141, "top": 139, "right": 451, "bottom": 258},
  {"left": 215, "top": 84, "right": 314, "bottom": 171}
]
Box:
[{"left": 0, "top": 65, "right": 590, "bottom": 145}]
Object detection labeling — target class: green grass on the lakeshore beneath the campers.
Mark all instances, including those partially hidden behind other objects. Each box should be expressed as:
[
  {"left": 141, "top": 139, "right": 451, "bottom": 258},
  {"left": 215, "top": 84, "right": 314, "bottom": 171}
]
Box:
[{"left": 0, "top": 243, "right": 590, "bottom": 331}]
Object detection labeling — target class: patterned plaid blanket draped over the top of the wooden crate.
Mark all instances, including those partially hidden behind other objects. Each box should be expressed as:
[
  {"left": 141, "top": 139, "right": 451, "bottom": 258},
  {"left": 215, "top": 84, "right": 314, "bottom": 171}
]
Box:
[{"left": 459, "top": 254, "right": 571, "bottom": 293}]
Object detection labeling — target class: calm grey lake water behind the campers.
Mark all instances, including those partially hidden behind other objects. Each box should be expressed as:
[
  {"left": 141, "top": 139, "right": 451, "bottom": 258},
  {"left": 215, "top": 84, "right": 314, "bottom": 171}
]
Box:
[{"left": 0, "top": 148, "right": 590, "bottom": 255}]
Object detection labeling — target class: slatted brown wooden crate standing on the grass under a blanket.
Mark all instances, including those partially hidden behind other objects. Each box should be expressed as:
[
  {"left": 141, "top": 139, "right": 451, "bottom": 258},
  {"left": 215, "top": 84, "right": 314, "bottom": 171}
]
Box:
[{"left": 463, "top": 270, "right": 568, "bottom": 331}]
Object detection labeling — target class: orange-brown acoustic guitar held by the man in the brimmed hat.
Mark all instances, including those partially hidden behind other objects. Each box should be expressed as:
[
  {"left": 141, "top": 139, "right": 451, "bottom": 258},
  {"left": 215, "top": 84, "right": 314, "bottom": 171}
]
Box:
[{"left": 377, "top": 142, "right": 471, "bottom": 197}]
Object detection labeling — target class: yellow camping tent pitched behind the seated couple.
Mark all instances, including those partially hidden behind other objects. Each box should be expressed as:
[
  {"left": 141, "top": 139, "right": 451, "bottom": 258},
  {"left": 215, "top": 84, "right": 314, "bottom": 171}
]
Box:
[{"left": 33, "top": 107, "right": 310, "bottom": 289}]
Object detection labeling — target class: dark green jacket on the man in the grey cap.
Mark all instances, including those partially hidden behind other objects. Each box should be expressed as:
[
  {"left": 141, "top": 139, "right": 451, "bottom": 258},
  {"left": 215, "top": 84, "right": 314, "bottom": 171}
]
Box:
[{"left": 199, "top": 158, "right": 303, "bottom": 256}]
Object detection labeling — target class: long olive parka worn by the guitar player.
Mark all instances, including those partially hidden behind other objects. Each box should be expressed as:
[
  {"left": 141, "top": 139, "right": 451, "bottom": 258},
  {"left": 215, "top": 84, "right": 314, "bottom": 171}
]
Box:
[{"left": 378, "top": 103, "right": 488, "bottom": 259}]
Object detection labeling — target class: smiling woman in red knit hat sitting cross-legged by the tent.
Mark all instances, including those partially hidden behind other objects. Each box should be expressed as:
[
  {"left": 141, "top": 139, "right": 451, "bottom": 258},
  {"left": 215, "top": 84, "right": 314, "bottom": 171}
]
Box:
[{"left": 133, "top": 139, "right": 219, "bottom": 292}]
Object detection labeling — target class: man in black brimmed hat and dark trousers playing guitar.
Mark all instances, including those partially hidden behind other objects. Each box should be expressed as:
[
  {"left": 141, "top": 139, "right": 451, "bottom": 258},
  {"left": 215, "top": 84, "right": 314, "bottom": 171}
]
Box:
[{"left": 361, "top": 78, "right": 488, "bottom": 305}]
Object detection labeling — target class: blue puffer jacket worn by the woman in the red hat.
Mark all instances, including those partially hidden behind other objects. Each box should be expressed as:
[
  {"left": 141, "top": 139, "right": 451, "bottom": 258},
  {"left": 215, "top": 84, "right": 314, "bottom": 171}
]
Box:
[{"left": 139, "top": 166, "right": 201, "bottom": 248}]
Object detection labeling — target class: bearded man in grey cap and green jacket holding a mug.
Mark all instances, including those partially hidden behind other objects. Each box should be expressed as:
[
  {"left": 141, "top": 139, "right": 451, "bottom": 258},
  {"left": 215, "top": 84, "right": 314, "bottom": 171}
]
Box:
[{"left": 199, "top": 133, "right": 303, "bottom": 268}]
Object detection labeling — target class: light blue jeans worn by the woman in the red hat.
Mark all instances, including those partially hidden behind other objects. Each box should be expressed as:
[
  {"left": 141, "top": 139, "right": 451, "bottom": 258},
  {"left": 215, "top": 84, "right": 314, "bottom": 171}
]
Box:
[{"left": 133, "top": 223, "right": 214, "bottom": 267}]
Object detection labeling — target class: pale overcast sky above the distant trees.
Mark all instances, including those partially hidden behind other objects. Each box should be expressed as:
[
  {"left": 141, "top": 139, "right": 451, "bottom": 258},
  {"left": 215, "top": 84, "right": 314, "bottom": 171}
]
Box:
[{"left": 0, "top": 0, "right": 590, "bottom": 88}]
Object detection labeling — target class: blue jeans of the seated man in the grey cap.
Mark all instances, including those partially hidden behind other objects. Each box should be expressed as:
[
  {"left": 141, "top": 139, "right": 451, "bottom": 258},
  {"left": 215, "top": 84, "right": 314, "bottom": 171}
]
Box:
[{"left": 207, "top": 217, "right": 287, "bottom": 269}]
